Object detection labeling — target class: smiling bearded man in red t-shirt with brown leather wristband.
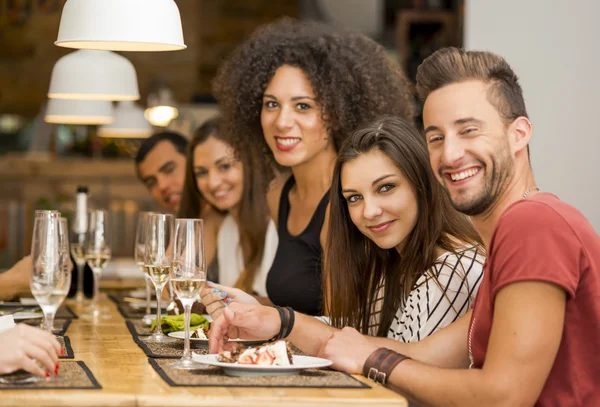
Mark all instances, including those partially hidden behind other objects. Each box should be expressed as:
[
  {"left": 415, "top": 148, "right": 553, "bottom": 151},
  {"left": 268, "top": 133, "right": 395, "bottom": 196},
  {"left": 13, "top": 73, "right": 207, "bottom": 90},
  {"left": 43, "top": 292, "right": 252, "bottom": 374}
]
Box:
[{"left": 321, "top": 48, "right": 600, "bottom": 407}]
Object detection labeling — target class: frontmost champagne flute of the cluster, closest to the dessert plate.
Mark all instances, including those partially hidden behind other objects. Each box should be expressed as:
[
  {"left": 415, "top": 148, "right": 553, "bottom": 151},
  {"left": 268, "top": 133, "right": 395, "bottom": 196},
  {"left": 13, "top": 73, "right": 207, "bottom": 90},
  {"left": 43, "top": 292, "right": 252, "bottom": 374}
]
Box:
[{"left": 170, "top": 219, "right": 207, "bottom": 369}]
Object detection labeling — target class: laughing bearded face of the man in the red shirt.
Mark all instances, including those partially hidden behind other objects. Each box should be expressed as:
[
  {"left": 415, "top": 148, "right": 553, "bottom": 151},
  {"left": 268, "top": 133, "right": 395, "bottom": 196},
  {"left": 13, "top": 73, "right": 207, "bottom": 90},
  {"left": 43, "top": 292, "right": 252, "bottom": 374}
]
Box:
[{"left": 423, "top": 80, "right": 514, "bottom": 216}]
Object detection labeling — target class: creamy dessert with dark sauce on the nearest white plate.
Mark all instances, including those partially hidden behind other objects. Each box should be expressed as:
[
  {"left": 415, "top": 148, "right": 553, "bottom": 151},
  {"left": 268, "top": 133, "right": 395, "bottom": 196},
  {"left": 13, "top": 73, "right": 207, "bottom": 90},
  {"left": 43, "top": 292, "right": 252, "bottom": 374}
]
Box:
[{"left": 218, "top": 340, "right": 293, "bottom": 366}]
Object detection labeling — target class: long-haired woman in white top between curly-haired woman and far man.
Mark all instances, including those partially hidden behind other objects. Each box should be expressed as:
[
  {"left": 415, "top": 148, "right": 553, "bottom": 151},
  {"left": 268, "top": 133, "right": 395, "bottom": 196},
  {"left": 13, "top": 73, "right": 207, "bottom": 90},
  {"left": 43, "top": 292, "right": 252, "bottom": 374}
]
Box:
[{"left": 179, "top": 117, "right": 277, "bottom": 297}]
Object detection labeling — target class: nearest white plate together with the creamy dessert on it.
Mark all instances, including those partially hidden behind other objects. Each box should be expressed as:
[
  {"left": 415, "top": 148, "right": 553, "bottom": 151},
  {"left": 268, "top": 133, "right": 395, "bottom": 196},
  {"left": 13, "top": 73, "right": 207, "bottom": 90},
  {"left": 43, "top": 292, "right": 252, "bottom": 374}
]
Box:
[{"left": 192, "top": 340, "right": 333, "bottom": 377}]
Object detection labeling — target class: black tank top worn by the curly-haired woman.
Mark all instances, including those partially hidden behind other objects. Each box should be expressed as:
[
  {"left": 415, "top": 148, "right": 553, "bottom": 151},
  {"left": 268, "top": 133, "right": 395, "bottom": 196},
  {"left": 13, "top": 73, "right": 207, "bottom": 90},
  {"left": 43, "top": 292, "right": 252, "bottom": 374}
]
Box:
[{"left": 267, "top": 176, "right": 329, "bottom": 315}]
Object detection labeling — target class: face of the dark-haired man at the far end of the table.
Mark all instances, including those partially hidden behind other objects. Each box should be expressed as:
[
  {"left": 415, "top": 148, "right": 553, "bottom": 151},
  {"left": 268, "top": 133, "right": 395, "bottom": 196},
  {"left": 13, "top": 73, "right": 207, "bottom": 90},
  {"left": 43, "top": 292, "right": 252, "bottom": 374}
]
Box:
[{"left": 138, "top": 140, "right": 185, "bottom": 212}]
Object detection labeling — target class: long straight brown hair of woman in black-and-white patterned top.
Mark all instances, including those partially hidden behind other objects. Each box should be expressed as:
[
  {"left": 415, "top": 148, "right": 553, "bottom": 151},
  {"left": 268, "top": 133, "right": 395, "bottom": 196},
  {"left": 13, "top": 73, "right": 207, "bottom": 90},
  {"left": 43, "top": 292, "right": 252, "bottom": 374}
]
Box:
[{"left": 323, "top": 116, "right": 481, "bottom": 336}]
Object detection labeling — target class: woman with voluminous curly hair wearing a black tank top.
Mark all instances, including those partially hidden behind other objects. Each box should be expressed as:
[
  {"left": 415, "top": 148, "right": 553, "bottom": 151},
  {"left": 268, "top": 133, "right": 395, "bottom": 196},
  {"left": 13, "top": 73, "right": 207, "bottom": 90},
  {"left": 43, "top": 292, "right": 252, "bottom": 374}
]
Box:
[{"left": 205, "top": 19, "right": 414, "bottom": 316}]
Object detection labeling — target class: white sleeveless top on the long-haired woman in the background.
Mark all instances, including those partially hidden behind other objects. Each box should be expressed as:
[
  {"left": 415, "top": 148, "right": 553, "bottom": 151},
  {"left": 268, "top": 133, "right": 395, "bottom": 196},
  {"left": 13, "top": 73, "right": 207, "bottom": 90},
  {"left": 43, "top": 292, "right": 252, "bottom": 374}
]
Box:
[{"left": 217, "top": 215, "right": 277, "bottom": 297}]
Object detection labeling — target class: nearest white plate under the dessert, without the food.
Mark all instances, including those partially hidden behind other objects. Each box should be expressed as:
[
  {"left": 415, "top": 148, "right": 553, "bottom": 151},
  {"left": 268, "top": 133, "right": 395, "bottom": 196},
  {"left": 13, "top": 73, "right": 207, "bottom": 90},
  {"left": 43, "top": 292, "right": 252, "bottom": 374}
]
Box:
[{"left": 192, "top": 353, "right": 333, "bottom": 377}]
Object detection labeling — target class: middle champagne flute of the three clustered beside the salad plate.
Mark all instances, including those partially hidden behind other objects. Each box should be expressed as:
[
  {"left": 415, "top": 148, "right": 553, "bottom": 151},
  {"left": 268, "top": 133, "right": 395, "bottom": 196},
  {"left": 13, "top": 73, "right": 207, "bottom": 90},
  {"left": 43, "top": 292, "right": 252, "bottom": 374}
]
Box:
[{"left": 144, "top": 213, "right": 175, "bottom": 343}]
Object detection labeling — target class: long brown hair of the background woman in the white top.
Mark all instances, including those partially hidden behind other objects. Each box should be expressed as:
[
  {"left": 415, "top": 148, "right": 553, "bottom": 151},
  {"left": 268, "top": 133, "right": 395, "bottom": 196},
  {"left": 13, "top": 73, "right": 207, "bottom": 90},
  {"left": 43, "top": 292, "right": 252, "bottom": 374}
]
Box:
[{"left": 178, "top": 116, "right": 269, "bottom": 293}]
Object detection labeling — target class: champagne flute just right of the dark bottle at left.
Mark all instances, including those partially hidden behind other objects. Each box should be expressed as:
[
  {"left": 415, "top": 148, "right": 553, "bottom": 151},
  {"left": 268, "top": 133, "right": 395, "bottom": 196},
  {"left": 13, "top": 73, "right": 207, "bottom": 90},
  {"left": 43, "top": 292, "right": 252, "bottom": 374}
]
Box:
[{"left": 84, "top": 210, "right": 111, "bottom": 320}]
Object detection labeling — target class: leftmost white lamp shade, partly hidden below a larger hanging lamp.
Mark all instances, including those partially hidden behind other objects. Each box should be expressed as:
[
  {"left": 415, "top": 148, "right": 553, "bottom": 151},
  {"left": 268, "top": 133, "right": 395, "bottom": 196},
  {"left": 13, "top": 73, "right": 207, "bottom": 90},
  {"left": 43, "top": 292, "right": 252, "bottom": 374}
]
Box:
[{"left": 44, "top": 99, "right": 114, "bottom": 124}]
